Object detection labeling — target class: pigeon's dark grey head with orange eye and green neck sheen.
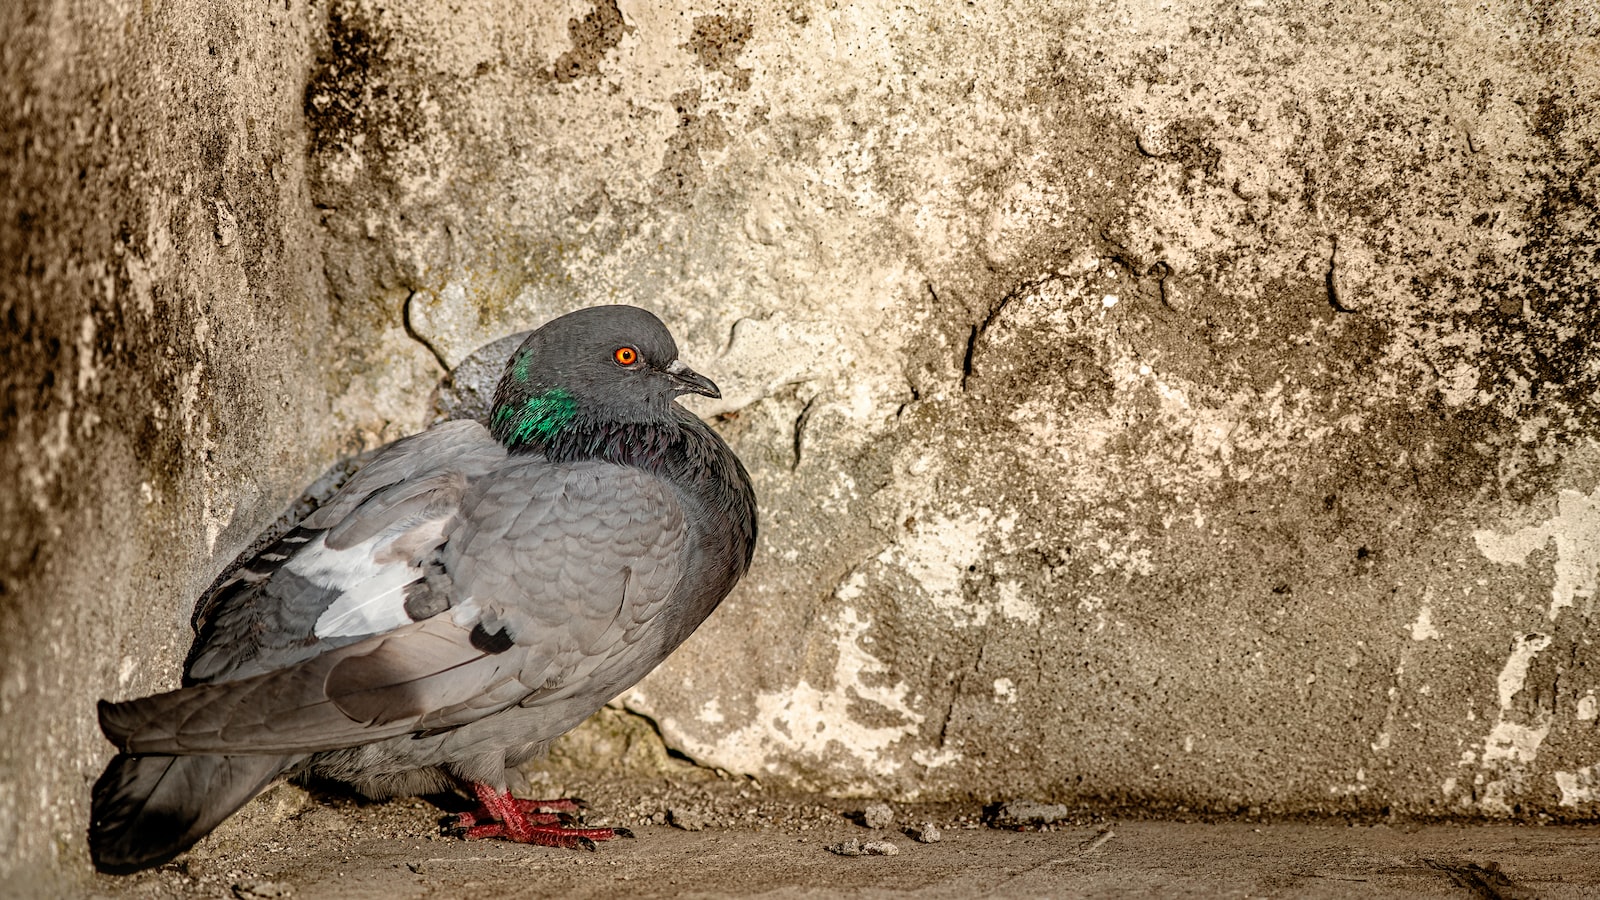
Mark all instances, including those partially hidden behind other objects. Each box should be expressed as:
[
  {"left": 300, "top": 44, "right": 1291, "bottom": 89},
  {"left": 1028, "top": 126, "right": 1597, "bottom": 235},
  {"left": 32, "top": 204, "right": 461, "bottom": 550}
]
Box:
[{"left": 490, "top": 306, "right": 722, "bottom": 450}]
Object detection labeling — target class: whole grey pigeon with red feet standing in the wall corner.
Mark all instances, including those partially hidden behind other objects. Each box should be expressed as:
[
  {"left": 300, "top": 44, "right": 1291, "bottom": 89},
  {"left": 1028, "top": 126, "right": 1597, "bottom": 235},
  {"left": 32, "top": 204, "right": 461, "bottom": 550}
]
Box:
[{"left": 88, "top": 306, "right": 757, "bottom": 873}]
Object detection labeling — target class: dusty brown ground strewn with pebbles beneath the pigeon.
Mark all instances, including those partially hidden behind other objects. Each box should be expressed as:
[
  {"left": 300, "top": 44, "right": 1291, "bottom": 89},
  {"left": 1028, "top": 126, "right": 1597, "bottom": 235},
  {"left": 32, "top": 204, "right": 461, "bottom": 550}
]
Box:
[{"left": 72, "top": 762, "right": 1600, "bottom": 900}]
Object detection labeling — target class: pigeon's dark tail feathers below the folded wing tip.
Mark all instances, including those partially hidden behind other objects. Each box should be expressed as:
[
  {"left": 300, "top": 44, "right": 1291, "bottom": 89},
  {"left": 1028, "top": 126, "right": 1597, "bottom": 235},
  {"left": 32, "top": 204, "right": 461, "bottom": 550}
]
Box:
[{"left": 90, "top": 753, "right": 294, "bottom": 874}]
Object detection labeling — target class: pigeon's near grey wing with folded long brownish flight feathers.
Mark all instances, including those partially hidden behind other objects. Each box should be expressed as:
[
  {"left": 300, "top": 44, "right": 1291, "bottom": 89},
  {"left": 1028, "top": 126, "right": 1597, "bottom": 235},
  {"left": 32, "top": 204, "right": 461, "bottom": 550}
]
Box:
[{"left": 101, "top": 458, "right": 685, "bottom": 754}]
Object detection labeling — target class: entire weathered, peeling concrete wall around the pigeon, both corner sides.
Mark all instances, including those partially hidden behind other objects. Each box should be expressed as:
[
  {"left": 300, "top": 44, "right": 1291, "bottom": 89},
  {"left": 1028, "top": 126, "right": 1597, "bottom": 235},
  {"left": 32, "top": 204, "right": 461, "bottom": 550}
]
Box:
[{"left": 0, "top": 0, "right": 1600, "bottom": 883}]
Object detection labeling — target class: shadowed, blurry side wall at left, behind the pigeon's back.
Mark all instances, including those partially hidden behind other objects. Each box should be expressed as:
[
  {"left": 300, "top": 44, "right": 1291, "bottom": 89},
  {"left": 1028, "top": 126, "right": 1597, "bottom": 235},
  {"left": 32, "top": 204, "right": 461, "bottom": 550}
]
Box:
[{"left": 0, "top": 0, "right": 437, "bottom": 897}]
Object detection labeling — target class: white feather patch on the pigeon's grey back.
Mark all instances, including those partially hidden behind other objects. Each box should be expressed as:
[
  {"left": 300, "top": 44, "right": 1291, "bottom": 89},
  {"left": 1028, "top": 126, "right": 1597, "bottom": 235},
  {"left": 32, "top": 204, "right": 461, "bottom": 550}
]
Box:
[{"left": 297, "top": 525, "right": 437, "bottom": 637}]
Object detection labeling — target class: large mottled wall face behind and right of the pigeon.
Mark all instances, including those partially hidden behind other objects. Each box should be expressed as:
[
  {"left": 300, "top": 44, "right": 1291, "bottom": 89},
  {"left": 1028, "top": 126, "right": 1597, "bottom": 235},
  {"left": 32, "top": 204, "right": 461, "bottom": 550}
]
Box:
[{"left": 324, "top": 2, "right": 1600, "bottom": 815}]
